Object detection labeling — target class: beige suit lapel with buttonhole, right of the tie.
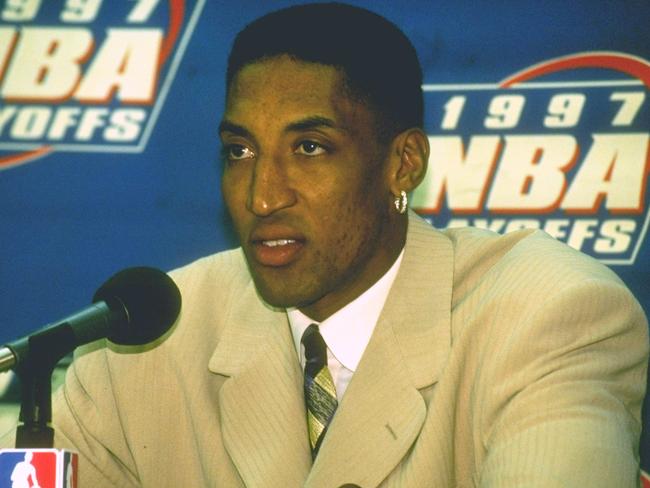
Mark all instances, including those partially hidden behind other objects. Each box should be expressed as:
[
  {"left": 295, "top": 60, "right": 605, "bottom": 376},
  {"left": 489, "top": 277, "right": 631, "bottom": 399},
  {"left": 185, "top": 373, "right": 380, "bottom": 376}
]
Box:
[{"left": 307, "top": 215, "right": 453, "bottom": 486}]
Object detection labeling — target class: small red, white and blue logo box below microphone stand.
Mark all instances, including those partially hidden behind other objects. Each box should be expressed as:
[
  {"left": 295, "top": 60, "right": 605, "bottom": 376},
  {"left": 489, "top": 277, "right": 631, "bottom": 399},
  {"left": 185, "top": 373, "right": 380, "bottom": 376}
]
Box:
[{"left": 0, "top": 449, "right": 78, "bottom": 488}]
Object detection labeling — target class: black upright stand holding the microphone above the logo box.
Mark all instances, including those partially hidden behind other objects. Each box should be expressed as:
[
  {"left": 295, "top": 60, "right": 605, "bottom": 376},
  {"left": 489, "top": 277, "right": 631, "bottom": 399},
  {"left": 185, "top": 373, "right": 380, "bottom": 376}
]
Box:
[{"left": 11, "top": 326, "right": 75, "bottom": 449}]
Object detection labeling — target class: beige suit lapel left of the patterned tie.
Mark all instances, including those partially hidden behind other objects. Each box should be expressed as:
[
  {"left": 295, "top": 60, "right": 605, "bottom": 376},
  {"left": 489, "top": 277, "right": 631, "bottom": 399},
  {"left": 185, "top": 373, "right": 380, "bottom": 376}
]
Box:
[{"left": 209, "top": 283, "right": 311, "bottom": 487}]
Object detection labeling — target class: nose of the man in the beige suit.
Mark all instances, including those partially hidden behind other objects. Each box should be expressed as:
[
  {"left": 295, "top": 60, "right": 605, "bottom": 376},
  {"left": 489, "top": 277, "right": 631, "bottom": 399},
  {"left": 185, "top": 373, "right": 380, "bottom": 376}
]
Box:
[{"left": 246, "top": 157, "right": 296, "bottom": 217}]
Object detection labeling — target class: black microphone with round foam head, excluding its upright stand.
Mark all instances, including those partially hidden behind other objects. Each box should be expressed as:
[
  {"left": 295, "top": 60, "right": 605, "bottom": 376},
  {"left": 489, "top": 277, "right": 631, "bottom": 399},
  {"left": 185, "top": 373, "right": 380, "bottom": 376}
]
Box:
[{"left": 0, "top": 267, "right": 181, "bottom": 373}]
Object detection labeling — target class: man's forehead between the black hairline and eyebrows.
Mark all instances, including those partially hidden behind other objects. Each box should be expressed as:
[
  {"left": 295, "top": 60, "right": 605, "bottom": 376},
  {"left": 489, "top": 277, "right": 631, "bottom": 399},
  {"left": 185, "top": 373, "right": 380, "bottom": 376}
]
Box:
[{"left": 225, "top": 55, "right": 372, "bottom": 133}]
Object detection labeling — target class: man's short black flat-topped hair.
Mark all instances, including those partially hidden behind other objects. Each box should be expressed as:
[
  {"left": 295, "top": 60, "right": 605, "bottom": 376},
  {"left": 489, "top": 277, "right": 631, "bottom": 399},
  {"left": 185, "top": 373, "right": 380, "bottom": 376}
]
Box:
[{"left": 226, "top": 3, "right": 424, "bottom": 137}]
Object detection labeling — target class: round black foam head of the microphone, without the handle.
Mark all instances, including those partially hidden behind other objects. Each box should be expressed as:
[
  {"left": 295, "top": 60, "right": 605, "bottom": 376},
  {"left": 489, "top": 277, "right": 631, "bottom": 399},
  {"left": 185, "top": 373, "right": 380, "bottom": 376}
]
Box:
[{"left": 93, "top": 267, "right": 181, "bottom": 346}]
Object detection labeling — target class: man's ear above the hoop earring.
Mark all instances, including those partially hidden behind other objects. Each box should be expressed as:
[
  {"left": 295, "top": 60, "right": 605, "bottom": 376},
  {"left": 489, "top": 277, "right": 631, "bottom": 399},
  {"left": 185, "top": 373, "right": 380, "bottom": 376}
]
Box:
[{"left": 390, "top": 127, "right": 429, "bottom": 196}]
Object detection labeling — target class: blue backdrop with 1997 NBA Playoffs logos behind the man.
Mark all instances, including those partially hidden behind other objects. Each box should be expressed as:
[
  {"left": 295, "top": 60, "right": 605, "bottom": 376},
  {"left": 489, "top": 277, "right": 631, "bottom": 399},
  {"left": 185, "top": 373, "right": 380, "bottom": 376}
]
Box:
[{"left": 0, "top": 0, "right": 650, "bottom": 480}]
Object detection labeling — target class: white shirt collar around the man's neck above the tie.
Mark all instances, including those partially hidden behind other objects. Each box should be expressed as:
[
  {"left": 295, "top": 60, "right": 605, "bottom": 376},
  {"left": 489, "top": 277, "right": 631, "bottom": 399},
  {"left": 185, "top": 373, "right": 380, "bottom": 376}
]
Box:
[{"left": 287, "top": 249, "right": 404, "bottom": 372}]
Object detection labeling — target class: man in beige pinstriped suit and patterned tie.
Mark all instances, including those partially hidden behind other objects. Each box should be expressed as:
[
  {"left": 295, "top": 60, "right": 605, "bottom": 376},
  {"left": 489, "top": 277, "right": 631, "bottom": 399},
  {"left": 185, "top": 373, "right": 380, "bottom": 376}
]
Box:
[{"left": 2, "top": 4, "right": 648, "bottom": 487}]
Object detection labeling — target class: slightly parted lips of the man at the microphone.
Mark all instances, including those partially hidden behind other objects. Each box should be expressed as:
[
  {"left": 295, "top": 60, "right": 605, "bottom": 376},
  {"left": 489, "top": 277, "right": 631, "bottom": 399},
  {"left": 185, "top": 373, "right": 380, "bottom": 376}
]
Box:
[{"left": 250, "top": 228, "right": 305, "bottom": 267}]
